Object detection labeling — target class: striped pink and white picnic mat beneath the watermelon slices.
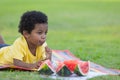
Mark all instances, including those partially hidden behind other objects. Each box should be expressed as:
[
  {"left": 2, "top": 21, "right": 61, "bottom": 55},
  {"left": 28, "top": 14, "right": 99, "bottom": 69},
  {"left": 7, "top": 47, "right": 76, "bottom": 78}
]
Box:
[{"left": 0, "top": 50, "right": 120, "bottom": 80}]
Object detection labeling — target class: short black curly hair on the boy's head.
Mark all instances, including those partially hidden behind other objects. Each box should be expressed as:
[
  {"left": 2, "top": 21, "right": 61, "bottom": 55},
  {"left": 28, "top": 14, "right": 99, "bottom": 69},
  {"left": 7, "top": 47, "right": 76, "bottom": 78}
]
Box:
[{"left": 18, "top": 11, "right": 48, "bottom": 34}]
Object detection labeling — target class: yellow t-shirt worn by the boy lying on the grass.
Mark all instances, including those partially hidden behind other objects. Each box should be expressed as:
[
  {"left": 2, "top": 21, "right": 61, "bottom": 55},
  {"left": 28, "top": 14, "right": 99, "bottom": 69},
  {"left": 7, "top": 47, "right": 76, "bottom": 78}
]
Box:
[{"left": 0, "top": 36, "right": 46, "bottom": 65}]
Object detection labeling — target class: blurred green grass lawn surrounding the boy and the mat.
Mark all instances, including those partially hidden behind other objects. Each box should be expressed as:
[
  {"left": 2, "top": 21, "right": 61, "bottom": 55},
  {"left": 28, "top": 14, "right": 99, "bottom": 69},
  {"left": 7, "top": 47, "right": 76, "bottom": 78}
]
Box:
[{"left": 0, "top": 0, "right": 120, "bottom": 80}]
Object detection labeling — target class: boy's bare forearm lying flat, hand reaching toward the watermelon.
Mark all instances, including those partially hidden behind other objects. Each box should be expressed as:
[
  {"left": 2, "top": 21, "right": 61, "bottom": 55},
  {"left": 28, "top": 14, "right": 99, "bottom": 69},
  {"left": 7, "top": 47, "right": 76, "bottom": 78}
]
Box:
[{"left": 13, "top": 59, "right": 42, "bottom": 69}]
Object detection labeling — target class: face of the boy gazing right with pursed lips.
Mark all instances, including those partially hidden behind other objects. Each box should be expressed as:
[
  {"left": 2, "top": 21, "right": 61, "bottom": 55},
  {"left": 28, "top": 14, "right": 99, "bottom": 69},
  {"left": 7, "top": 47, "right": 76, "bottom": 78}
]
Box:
[{"left": 26, "top": 24, "right": 48, "bottom": 47}]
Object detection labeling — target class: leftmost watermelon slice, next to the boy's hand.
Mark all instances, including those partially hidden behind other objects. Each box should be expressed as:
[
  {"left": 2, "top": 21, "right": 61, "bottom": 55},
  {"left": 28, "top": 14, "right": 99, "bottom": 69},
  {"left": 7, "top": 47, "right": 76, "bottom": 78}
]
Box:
[{"left": 38, "top": 60, "right": 55, "bottom": 75}]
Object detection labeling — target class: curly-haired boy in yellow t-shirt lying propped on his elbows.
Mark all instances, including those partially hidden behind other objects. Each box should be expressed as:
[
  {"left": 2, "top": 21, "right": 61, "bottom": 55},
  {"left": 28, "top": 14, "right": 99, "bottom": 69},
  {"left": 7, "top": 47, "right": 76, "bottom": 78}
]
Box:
[{"left": 0, "top": 11, "right": 52, "bottom": 69}]
